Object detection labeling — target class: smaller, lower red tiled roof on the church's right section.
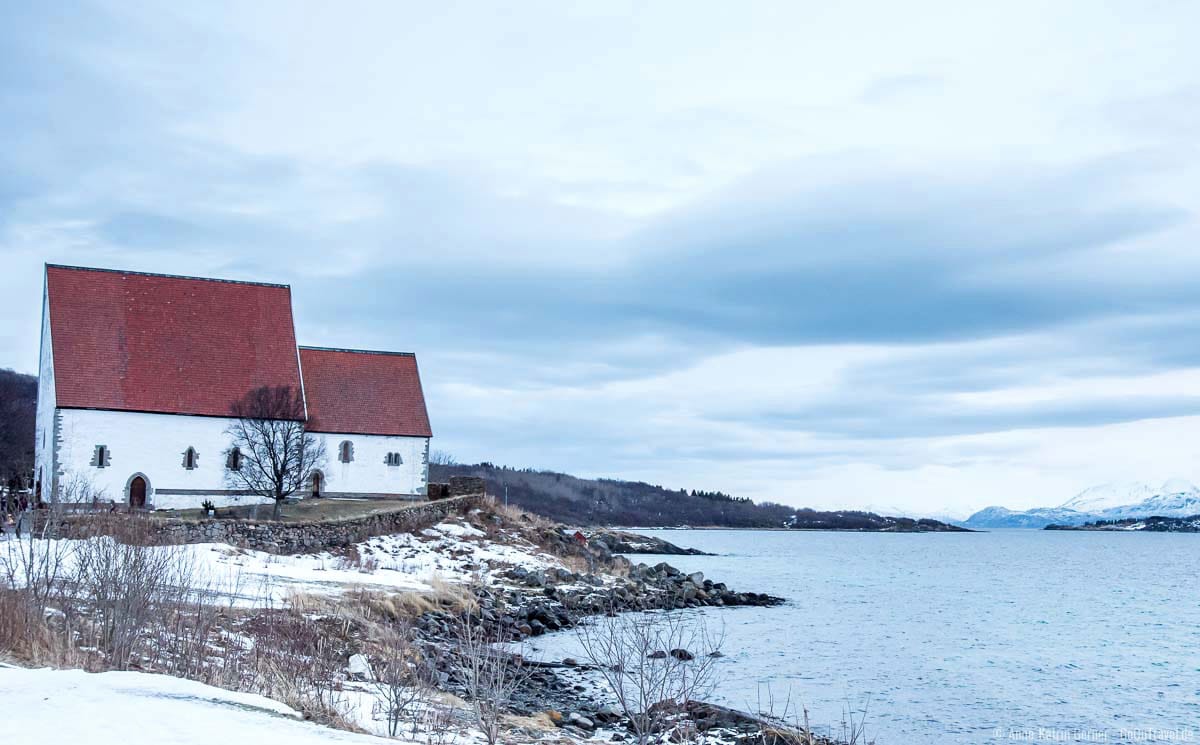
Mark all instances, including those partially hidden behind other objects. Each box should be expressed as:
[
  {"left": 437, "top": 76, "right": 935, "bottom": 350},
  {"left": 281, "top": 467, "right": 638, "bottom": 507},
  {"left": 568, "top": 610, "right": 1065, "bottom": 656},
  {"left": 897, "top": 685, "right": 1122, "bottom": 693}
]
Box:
[{"left": 300, "top": 347, "right": 433, "bottom": 437}]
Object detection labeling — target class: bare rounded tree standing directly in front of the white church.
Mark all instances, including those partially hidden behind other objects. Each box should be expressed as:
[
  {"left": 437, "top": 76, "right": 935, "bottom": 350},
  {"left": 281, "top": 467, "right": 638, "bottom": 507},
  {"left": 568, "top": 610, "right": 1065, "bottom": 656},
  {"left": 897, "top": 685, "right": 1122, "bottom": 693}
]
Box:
[{"left": 224, "top": 385, "right": 325, "bottom": 519}]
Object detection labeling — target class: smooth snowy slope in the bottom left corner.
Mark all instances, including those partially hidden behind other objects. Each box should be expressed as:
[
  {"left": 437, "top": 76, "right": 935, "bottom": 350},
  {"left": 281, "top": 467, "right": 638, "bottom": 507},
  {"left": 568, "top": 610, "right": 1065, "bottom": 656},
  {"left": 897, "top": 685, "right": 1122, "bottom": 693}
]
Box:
[{"left": 0, "top": 667, "right": 401, "bottom": 745}]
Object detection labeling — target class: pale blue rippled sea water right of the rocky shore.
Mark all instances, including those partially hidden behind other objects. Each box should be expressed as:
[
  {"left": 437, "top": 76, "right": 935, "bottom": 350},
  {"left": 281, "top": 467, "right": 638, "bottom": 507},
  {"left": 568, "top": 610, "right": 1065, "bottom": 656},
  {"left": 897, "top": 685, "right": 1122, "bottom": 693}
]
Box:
[{"left": 525, "top": 530, "right": 1200, "bottom": 745}]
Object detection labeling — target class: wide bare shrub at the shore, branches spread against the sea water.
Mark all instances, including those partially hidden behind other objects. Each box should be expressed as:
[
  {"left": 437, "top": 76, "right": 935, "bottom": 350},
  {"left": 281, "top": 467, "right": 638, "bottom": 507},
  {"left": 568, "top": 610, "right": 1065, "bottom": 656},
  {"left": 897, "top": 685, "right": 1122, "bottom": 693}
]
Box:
[{"left": 576, "top": 612, "right": 724, "bottom": 745}]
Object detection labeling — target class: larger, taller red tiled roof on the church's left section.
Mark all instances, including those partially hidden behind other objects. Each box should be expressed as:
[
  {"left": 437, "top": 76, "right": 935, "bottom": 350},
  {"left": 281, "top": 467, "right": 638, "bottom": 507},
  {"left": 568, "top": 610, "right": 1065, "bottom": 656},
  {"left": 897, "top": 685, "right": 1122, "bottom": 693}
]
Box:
[{"left": 46, "top": 265, "right": 300, "bottom": 416}]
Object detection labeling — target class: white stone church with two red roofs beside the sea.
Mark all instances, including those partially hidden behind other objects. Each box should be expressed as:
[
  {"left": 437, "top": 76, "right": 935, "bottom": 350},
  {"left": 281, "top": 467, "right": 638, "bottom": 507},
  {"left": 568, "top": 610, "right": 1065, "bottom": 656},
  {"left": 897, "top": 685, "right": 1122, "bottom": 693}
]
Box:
[{"left": 35, "top": 265, "right": 432, "bottom": 509}]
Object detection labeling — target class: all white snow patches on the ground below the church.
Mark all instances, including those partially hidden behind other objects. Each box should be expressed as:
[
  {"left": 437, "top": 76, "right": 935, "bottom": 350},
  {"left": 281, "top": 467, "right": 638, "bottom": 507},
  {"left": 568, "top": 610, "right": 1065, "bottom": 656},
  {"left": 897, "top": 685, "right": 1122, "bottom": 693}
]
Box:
[{"left": 0, "top": 517, "right": 633, "bottom": 745}]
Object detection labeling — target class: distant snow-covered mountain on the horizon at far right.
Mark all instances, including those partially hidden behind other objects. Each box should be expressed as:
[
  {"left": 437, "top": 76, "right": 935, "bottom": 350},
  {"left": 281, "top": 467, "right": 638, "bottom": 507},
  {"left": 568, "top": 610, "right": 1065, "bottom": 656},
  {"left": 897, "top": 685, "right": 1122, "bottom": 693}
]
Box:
[{"left": 964, "top": 479, "right": 1200, "bottom": 528}]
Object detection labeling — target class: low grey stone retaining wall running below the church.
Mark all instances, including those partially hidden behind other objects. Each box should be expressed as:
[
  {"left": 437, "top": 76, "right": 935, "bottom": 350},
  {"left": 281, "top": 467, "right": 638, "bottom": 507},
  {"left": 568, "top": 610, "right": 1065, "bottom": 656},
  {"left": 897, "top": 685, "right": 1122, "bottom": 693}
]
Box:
[{"left": 42, "top": 494, "right": 487, "bottom": 553}]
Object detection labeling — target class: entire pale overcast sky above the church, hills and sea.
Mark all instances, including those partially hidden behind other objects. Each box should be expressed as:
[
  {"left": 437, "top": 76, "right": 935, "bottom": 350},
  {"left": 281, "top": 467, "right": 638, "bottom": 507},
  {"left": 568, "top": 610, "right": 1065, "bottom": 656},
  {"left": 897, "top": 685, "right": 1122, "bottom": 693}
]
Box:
[{"left": 0, "top": 0, "right": 1200, "bottom": 513}]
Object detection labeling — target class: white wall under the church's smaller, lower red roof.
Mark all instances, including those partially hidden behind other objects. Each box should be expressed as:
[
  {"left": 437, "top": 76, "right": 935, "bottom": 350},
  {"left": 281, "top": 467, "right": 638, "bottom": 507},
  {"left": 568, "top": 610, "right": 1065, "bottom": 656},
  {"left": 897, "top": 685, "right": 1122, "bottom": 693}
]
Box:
[{"left": 319, "top": 433, "right": 430, "bottom": 497}]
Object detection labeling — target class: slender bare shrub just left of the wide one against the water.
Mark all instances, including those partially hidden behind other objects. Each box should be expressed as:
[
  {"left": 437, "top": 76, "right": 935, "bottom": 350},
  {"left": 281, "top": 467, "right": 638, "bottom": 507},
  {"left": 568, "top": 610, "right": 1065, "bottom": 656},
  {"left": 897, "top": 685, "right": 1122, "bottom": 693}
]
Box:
[{"left": 449, "top": 614, "right": 529, "bottom": 745}]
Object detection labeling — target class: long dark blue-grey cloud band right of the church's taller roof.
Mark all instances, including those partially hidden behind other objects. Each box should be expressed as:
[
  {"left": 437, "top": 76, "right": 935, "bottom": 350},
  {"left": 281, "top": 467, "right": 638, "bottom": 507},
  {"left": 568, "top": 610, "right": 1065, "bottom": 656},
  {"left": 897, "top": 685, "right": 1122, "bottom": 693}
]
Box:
[{"left": 280, "top": 153, "right": 1196, "bottom": 381}]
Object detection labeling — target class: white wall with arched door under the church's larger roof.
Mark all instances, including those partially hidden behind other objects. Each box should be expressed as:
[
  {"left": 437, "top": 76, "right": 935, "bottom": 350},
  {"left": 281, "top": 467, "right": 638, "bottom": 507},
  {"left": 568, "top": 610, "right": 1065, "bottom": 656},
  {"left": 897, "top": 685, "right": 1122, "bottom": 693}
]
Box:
[{"left": 59, "top": 409, "right": 265, "bottom": 510}]
